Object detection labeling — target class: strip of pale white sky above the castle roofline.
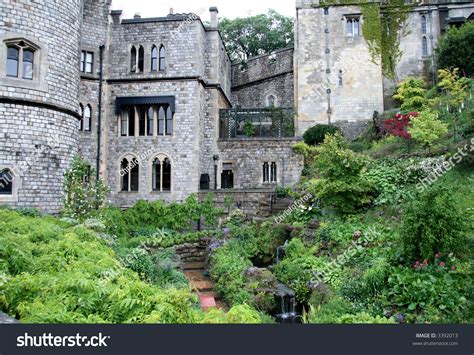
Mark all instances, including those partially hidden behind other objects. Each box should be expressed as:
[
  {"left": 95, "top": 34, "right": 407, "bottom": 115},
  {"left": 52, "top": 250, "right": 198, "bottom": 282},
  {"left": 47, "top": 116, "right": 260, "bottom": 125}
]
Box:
[{"left": 112, "top": 0, "right": 296, "bottom": 21}]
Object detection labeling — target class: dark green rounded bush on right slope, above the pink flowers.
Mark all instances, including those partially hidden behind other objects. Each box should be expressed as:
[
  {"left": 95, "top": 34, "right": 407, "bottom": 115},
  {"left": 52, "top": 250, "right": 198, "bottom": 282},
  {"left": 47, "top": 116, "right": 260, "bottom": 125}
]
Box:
[{"left": 400, "top": 185, "right": 466, "bottom": 263}]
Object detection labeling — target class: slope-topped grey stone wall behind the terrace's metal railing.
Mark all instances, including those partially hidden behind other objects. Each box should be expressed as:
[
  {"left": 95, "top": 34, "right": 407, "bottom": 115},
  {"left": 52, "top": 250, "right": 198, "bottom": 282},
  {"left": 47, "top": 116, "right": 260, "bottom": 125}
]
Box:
[{"left": 232, "top": 48, "right": 294, "bottom": 108}]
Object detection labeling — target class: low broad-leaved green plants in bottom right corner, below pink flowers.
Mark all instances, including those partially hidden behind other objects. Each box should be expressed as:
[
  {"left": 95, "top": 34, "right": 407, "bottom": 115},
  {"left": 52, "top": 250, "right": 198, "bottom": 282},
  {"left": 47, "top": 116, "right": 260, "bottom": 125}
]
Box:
[{"left": 384, "top": 268, "right": 467, "bottom": 323}]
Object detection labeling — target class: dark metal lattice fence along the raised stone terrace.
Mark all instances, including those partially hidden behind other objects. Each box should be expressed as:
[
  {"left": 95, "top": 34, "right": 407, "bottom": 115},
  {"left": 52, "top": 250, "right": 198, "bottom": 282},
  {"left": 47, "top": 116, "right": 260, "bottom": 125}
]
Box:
[{"left": 219, "top": 108, "right": 295, "bottom": 140}]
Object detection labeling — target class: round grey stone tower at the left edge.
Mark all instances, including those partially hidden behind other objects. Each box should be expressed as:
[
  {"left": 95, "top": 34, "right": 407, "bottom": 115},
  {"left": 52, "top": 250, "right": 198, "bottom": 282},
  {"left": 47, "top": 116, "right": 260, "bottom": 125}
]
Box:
[{"left": 0, "top": 0, "right": 82, "bottom": 213}]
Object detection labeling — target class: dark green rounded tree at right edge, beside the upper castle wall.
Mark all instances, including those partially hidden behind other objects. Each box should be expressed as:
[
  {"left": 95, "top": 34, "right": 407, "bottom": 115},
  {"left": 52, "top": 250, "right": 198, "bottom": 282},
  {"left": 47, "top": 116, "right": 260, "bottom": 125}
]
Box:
[{"left": 436, "top": 22, "right": 474, "bottom": 76}]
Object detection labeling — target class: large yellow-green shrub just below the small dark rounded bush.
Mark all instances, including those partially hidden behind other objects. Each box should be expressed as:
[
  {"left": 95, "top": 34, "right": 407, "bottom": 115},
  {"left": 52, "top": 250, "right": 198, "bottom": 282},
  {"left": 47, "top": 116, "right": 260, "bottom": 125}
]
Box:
[{"left": 309, "top": 134, "right": 373, "bottom": 213}]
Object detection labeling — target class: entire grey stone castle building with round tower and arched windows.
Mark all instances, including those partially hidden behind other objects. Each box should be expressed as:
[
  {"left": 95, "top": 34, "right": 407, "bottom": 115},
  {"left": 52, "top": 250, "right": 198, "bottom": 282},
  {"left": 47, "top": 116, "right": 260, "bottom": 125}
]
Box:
[{"left": 0, "top": 0, "right": 473, "bottom": 213}]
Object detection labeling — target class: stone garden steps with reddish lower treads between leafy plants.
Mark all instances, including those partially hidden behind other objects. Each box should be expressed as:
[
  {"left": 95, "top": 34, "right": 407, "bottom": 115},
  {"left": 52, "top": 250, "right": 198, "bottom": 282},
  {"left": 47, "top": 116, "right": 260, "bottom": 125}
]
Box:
[{"left": 181, "top": 259, "right": 227, "bottom": 311}]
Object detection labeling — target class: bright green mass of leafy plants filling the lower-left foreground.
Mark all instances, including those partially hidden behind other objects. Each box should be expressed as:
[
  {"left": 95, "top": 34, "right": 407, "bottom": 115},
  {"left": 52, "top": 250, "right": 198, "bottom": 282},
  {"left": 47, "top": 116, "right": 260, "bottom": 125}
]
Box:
[{"left": 0, "top": 211, "right": 199, "bottom": 323}]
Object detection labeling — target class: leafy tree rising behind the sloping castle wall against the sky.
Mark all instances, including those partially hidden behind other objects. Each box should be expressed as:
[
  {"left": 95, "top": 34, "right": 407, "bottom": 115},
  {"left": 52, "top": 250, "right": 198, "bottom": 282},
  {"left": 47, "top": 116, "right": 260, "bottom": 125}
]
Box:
[{"left": 219, "top": 10, "right": 294, "bottom": 61}]
